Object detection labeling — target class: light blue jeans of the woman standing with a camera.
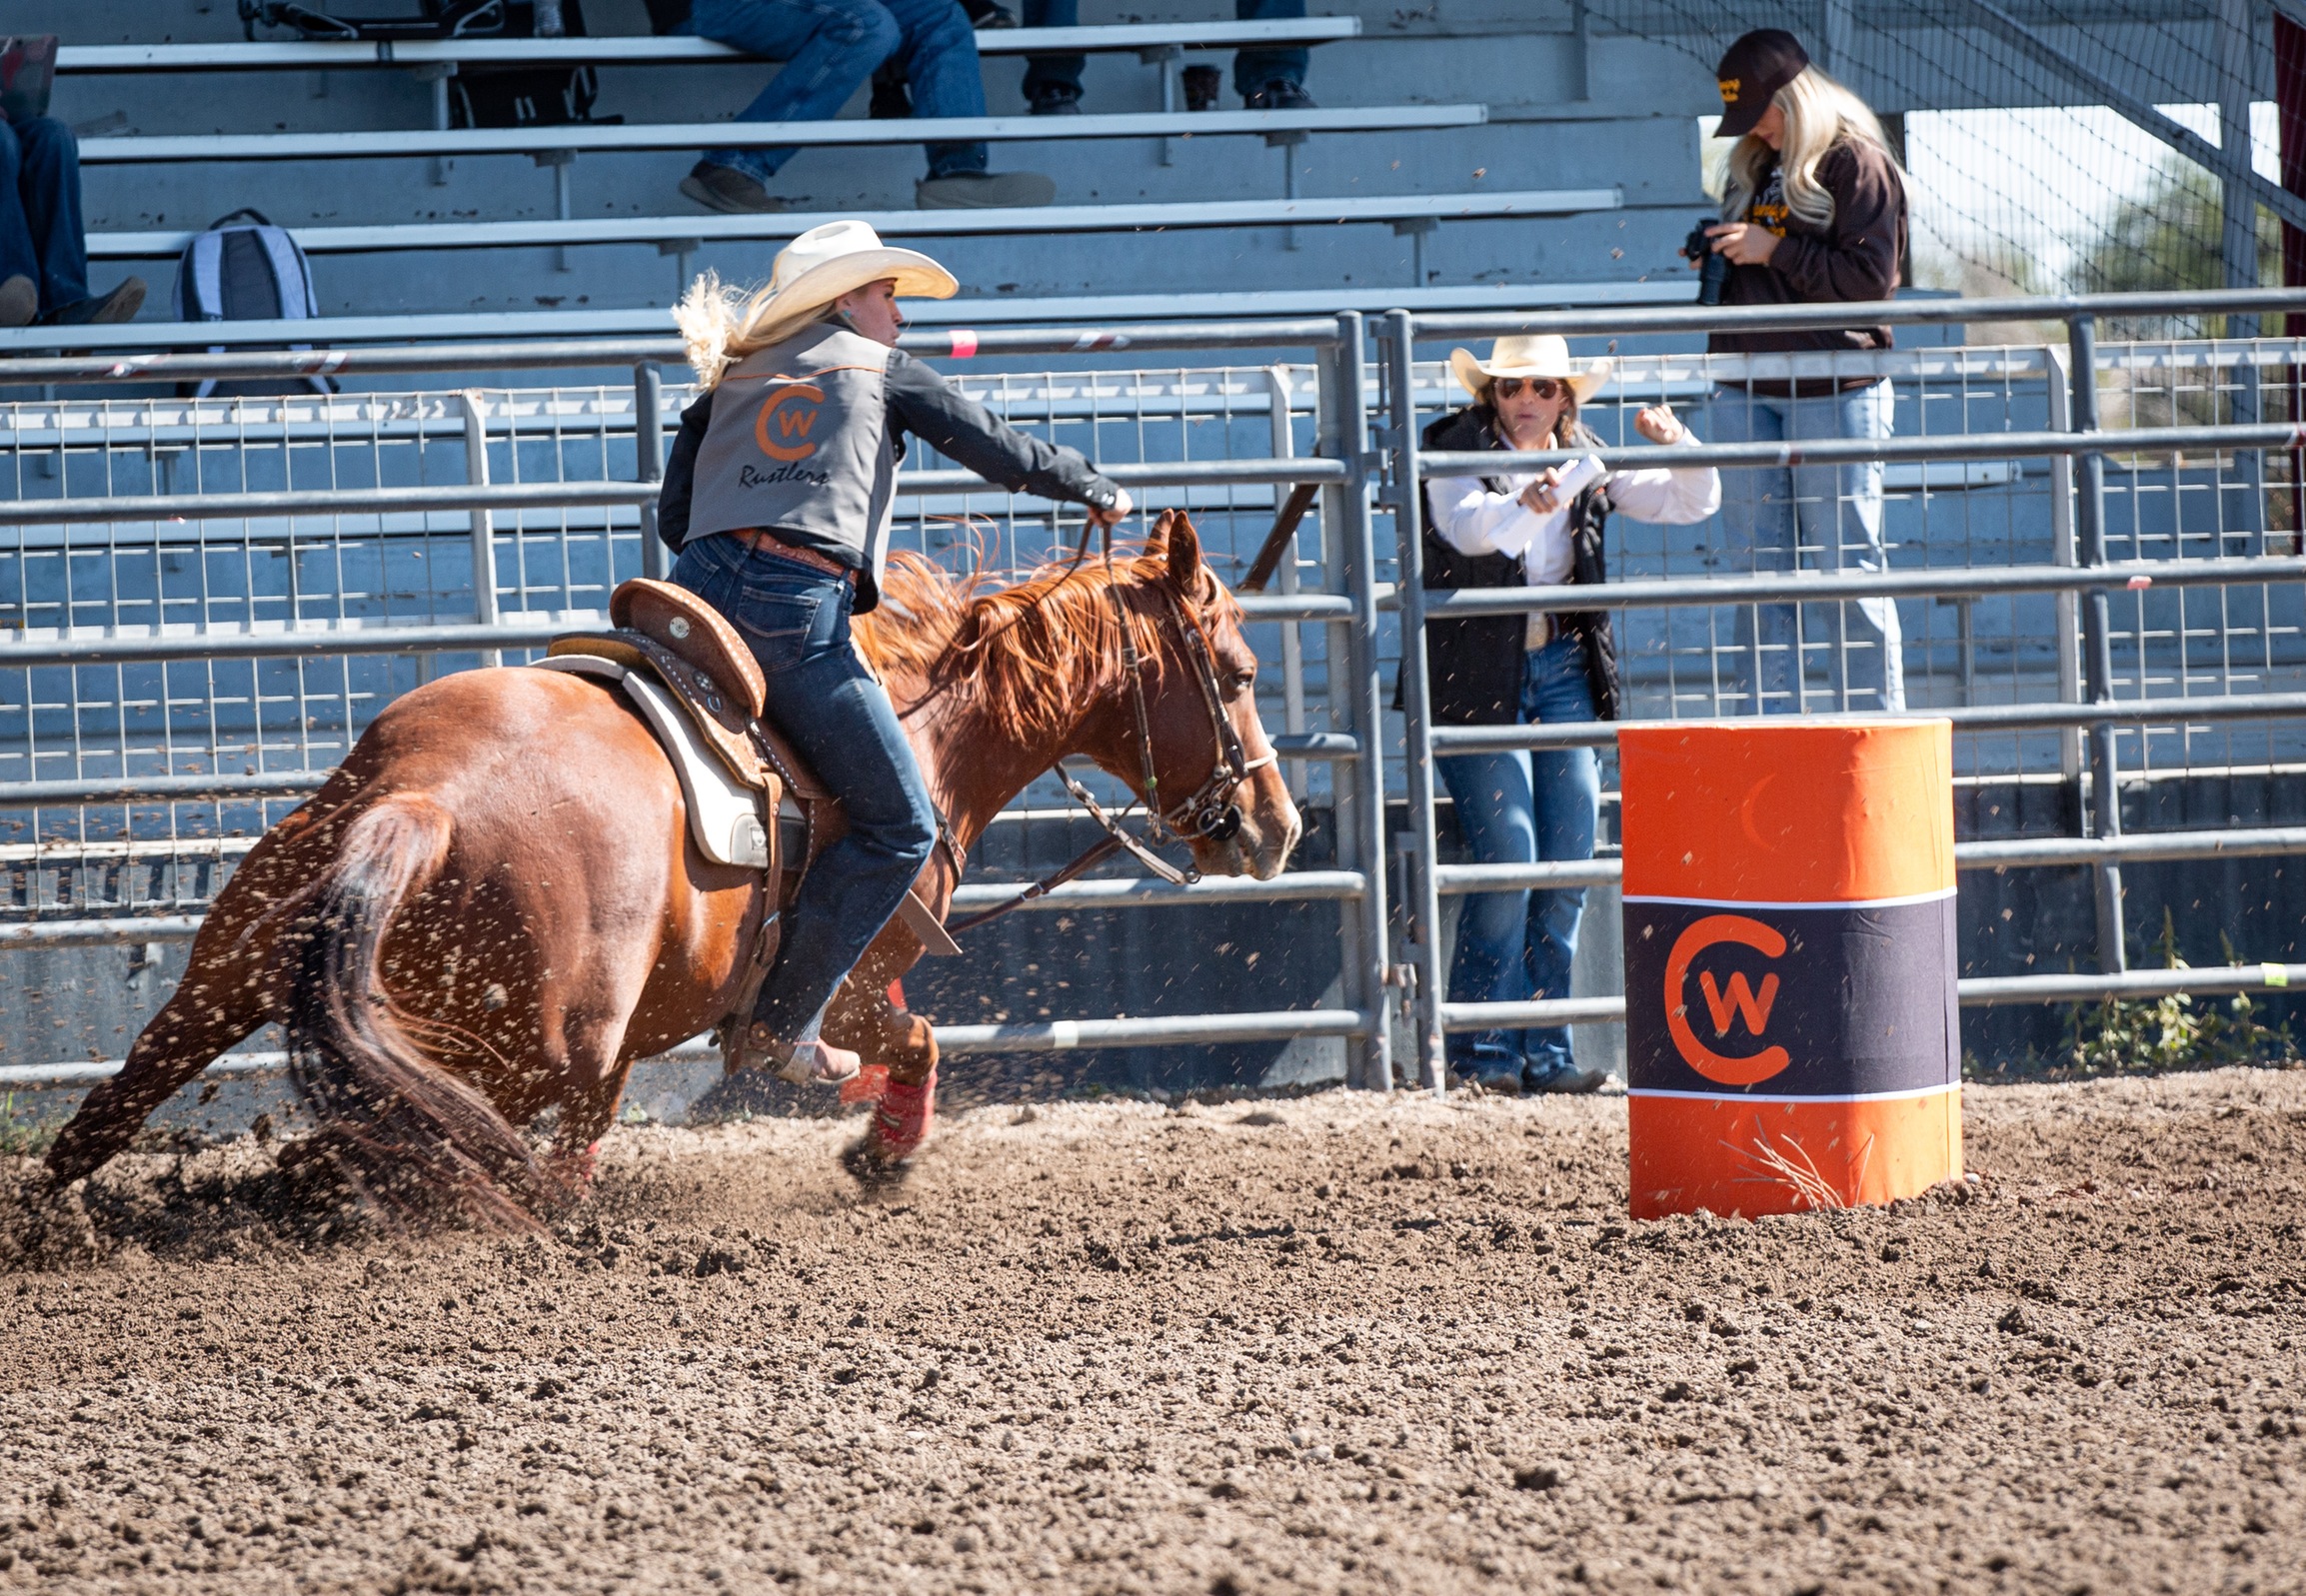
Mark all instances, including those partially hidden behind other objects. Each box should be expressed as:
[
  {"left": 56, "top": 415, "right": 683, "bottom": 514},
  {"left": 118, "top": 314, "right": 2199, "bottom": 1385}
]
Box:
[{"left": 1706, "top": 381, "right": 1905, "bottom": 715}]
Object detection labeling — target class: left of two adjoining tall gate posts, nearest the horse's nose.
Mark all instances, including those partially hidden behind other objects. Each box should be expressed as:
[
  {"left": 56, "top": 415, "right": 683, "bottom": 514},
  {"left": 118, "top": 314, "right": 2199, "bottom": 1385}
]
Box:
[{"left": 1328, "top": 312, "right": 1392, "bottom": 1091}]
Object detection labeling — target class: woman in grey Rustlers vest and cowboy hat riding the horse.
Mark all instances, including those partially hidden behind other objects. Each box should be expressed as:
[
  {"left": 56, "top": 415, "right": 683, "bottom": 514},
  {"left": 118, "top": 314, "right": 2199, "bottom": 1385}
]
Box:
[{"left": 657, "top": 222, "right": 1130, "bottom": 1097}]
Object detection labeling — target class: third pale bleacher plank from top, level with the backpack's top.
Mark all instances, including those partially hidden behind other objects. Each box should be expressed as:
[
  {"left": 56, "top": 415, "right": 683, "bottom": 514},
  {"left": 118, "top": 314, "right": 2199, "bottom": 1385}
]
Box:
[{"left": 88, "top": 189, "right": 1625, "bottom": 261}]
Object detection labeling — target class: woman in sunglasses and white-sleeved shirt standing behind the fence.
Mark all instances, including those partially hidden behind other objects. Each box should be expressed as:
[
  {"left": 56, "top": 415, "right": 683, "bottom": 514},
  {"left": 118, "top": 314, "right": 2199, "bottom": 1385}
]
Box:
[{"left": 1422, "top": 335, "right": 1720, "bottom": 1091}]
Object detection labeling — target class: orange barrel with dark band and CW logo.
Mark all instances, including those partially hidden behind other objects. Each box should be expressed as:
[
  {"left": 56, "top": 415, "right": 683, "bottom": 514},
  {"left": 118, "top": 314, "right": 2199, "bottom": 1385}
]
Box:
[{"left": 1619, "top": 720, "right": 1962, "bottom": 1218}]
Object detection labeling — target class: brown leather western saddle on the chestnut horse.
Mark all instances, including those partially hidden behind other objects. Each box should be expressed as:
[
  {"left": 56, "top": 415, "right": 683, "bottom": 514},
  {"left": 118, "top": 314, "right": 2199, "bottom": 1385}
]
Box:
[{"left": 544, "top": 577, "right": 960, "bottom": 1068}]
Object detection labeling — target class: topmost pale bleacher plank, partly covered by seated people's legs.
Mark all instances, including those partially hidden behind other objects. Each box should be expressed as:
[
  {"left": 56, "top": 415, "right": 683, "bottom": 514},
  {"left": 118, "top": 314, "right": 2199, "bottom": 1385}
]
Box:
[{"left": 55, "top": 16, "right": 1360, "bottom": 72}]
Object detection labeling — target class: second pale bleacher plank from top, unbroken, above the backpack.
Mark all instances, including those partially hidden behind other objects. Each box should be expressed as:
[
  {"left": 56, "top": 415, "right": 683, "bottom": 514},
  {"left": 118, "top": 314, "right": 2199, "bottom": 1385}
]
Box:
[{"left": 81, "top": 104, "right": 1489, "bottom": 166}]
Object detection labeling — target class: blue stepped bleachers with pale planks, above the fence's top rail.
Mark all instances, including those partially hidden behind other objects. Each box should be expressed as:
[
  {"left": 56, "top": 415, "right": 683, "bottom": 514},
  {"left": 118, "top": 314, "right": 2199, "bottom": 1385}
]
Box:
[{"left": 18, "top": 0, "right": 1697, "bottom": 327}]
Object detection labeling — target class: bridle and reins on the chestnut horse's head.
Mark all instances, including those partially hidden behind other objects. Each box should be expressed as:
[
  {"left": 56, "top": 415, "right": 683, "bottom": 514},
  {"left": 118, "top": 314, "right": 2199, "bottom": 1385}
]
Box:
[{"left": 946, "top": 533, "right": 1275, "bottom": 934}]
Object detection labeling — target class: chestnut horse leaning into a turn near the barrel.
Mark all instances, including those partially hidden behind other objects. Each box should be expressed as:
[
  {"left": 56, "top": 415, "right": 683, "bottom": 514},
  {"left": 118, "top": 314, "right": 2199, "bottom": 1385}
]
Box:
[{"left": 48, "top": 512, "right": 1298, "bottom": 1224}]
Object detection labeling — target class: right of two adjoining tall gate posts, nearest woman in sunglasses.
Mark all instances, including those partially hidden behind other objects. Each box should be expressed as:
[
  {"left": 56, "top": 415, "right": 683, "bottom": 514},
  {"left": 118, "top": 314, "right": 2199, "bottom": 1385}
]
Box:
[{"left": 1386, "top": 312, "right": 1448, "bottom": 1093}]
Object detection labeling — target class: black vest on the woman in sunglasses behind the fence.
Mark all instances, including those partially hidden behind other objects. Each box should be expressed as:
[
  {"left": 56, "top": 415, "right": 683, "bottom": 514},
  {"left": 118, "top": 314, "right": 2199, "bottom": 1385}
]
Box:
[{"left": 1418, "top": 404, "right": 1619, "bottom": 727}]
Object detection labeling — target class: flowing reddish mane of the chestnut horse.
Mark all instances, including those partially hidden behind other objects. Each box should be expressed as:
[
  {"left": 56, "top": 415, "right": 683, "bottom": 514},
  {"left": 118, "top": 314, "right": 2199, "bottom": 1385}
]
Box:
[{"left": 856, "top": 545, "right": 1240, "bottom": 734}]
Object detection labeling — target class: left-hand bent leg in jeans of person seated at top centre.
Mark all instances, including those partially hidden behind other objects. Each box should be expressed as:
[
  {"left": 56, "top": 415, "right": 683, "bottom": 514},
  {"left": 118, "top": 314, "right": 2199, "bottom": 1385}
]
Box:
[{"left": 681, "top": 0, "right": 895, "bottom": 212}]
